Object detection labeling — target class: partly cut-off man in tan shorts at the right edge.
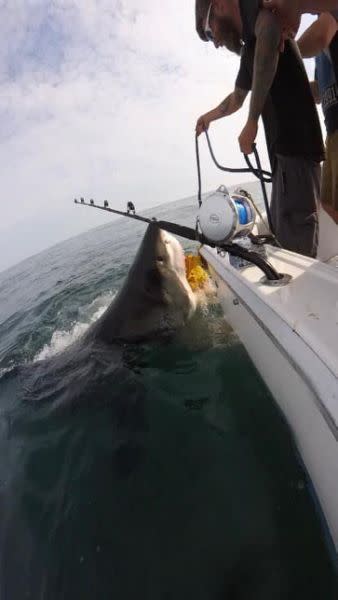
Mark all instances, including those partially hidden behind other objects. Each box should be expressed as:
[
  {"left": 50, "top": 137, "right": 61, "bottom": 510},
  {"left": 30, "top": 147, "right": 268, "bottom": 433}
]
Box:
[{"left": 298, "top": 12, "right": 338, "bottom": 260}]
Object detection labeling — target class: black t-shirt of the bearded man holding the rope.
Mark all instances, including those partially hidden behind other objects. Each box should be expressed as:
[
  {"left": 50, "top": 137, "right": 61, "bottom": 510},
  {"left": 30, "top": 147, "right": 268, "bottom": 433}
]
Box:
[{"left": 236, "top": 0, "right": 324, "bottom": 165}]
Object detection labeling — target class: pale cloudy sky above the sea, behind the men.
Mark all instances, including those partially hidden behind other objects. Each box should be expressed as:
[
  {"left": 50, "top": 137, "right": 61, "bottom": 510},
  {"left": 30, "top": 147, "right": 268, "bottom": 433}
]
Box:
[{"left": 0, "top": 0, "right": 316, "bottom": 271}]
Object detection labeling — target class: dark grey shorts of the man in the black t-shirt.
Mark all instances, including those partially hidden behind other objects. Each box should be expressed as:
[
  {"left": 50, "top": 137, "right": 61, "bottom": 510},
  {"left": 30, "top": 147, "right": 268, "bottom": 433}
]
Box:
[{"left": 271, "top": 154, "right": 320, "bottom": 257}]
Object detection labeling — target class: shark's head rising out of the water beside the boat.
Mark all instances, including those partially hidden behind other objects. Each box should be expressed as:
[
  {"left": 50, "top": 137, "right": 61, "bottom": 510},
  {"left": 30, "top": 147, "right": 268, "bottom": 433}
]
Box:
[{"left": 86, "top": 223, "right": 196, "bottom": 344}]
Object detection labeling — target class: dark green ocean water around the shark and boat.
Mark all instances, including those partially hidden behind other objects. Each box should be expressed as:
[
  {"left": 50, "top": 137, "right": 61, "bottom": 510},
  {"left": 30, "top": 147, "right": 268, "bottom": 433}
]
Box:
[{"left": 0, "top": 187, "right": 337, "bottom": 600}]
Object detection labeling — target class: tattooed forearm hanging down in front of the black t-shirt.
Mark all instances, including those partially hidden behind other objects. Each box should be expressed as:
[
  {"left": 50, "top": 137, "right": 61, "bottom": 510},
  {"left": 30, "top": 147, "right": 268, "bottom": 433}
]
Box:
[{"left": 249, "top": 10, "right": 281, "bottom": 121}]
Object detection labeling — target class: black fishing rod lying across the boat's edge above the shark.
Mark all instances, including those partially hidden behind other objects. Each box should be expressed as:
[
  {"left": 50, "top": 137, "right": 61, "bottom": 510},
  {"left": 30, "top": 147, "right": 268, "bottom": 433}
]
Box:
[{"left": 74, "top": 198, "right": 283, "bottom": 281}]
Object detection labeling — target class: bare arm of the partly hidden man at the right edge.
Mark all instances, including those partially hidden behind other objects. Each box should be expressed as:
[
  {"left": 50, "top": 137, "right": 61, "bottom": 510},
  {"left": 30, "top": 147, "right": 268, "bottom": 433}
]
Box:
[{"left": 297, "top": 13, "right": 337, "bottom": 58}]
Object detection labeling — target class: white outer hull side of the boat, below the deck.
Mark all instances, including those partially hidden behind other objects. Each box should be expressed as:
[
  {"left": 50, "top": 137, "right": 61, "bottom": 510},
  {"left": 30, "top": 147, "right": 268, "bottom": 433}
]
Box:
[{"left": 201, "top": 247, "right": 338, "bottom": 557}]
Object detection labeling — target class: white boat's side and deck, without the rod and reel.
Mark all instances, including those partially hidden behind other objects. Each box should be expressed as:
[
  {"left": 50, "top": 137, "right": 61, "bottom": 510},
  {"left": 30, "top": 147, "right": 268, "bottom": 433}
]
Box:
[{"left": 200, "top": 192, "right": 338, "bottom": 558}]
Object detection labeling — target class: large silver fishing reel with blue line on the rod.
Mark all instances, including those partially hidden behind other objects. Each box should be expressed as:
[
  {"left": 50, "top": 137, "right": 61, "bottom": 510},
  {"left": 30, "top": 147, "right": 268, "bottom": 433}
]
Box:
[{"left": 198, "top": 185, "right": 256, "bottom": 244}]
